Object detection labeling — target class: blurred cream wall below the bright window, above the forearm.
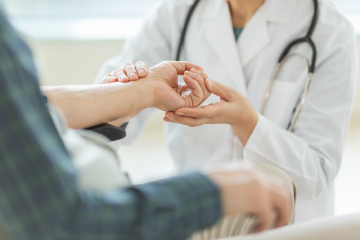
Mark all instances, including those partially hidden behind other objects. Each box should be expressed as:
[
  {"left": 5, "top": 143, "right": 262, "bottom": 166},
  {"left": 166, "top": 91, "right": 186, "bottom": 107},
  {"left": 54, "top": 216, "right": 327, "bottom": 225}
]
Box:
[{"left": 28, "top": 40, "right": 124, "bottom": 85}]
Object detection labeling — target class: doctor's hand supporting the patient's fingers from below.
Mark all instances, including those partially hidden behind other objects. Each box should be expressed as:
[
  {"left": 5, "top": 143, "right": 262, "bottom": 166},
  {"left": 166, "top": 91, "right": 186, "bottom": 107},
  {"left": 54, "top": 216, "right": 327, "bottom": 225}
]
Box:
[{"left": 164, "top": 79, "right": 259, "bottom": 146}]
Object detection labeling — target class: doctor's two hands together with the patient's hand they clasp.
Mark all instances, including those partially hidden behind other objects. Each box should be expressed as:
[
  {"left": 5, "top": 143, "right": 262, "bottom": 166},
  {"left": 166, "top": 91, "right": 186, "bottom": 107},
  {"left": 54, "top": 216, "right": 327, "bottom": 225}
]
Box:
[{"left": 101, "top": 62, "right": 258, "bottom": 146}]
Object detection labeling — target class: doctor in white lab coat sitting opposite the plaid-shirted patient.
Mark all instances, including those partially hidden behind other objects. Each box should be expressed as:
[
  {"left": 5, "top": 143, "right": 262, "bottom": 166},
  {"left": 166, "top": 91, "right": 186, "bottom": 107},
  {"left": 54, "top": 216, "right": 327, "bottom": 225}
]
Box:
[{"left": 96, "top": 0, "right": 357, "bottom": 222}]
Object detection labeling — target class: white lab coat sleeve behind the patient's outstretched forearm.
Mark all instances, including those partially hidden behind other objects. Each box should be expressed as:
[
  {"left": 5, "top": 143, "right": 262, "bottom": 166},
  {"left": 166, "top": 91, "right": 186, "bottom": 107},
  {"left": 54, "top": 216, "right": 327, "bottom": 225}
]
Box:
[{"left": 94, "top": 1, "right": 176, "bottom": 148}]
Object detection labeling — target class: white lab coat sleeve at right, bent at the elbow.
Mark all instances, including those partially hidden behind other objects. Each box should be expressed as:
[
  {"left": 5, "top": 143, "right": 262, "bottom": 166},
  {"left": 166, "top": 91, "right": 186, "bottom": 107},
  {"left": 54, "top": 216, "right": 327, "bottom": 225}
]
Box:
[{"left": 244, "top": 22, "right": 357, "bottom": 200}]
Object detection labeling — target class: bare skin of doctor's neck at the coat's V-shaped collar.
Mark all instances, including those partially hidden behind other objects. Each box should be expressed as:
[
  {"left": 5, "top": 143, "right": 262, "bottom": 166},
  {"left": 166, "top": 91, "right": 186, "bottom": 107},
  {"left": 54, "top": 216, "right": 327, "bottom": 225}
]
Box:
[{"left": 226, "top": 0, "right": 265, "bottom": 27}]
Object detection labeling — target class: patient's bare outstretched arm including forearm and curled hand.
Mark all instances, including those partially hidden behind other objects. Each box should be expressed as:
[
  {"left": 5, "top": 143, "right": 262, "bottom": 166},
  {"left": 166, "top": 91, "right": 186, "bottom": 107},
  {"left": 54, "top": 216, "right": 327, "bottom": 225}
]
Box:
[{"left": 42, "top": 62, "right": 210, "bottom": 129}]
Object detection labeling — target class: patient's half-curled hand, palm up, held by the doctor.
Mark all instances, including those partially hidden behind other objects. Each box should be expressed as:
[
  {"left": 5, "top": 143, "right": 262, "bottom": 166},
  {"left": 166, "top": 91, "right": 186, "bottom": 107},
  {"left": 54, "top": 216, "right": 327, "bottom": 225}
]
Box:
[{"left": 143, "top": 62, "right": 211, "bottom": 111}]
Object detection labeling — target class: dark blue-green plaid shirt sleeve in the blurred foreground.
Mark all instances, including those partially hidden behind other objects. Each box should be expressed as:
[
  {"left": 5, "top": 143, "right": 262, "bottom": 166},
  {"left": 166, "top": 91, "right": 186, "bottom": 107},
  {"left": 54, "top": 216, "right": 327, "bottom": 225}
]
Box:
[{"left": 0, "top": 11, "right": 222, "bottom": 240}]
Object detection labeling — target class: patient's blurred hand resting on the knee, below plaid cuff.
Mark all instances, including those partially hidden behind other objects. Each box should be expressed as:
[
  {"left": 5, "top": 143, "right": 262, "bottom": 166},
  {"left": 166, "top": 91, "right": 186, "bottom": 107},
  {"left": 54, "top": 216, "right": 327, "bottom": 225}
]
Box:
[{"left": 205, "top": 164, "right": 291, "bottom": 233}]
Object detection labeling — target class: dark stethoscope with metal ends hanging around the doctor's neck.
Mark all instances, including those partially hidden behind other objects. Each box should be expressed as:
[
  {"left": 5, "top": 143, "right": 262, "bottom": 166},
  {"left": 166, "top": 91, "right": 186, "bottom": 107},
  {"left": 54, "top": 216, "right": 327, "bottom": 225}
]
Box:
[{"left": 176, "top": 0, "right": 319, "bottom": 131}]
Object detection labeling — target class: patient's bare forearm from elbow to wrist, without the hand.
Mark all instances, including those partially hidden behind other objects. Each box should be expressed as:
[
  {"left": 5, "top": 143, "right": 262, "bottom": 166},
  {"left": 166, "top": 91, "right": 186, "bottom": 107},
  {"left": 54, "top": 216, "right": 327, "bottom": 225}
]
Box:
[{"left": 42, "top": 81, "right": 153, "bottom": 129}]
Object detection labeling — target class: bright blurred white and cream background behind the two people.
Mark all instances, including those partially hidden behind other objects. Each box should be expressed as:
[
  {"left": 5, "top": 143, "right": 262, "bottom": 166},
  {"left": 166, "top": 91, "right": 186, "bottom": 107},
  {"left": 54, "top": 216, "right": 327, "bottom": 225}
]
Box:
[{"left": 3, "top": 0, "right": 360, "bottom": 218}]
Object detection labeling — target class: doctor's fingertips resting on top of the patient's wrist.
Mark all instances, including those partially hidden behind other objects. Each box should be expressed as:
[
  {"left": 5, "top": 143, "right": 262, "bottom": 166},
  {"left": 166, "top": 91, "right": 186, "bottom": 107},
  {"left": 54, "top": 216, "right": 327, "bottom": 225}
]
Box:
[{"left": 100, "top": 61, "right": 148, "bottom": 84}]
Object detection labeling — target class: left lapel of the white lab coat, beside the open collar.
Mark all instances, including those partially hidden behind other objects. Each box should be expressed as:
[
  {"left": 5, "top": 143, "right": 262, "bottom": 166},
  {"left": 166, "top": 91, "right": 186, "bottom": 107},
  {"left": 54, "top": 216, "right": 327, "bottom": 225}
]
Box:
[{"left": 203, "top": 0, "right": 247, "bottom": 96}]
